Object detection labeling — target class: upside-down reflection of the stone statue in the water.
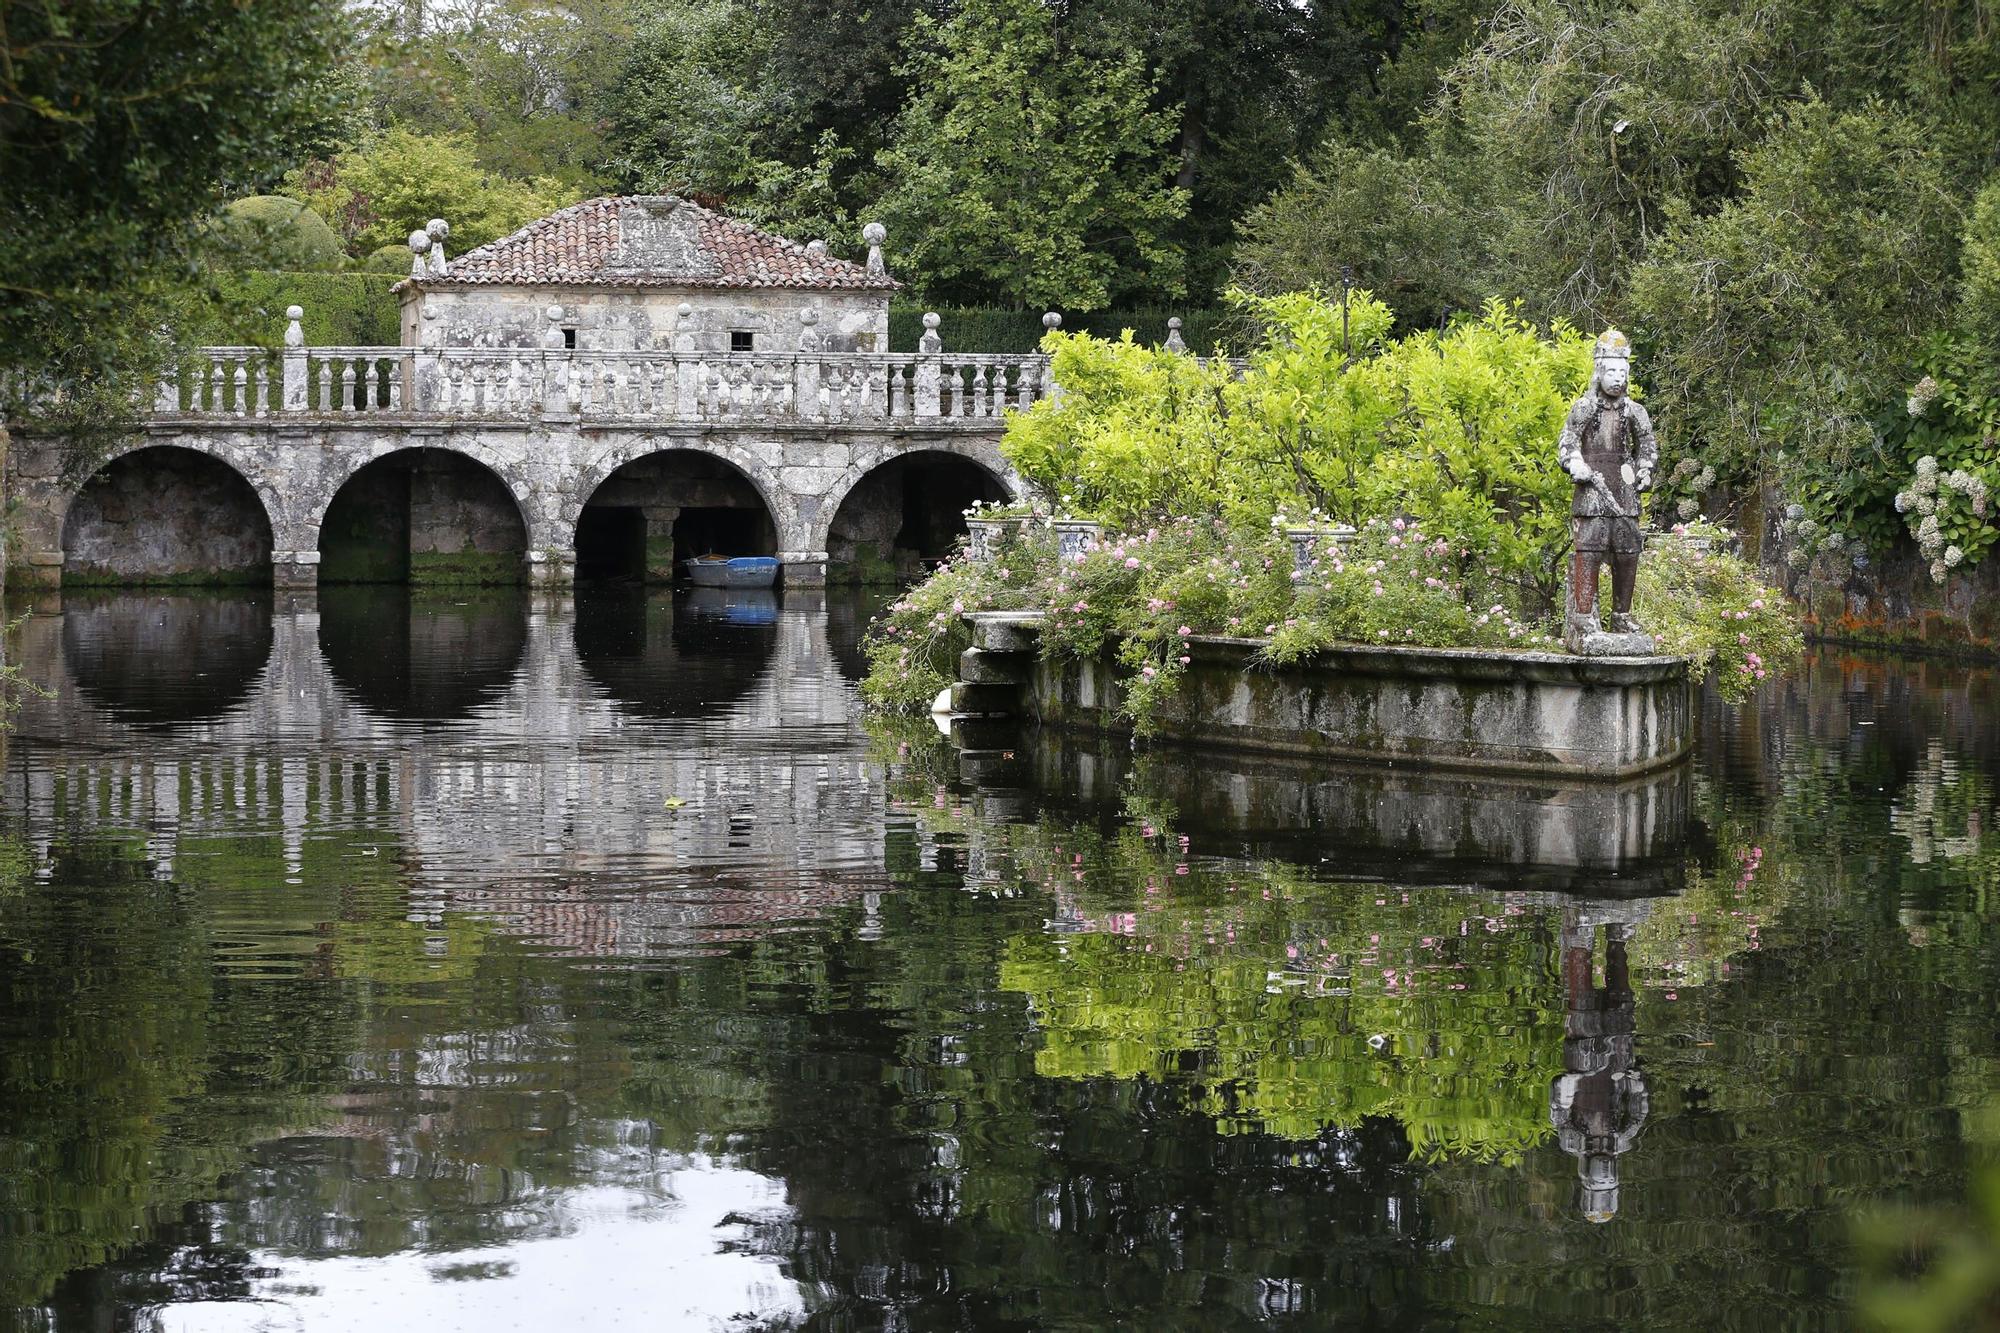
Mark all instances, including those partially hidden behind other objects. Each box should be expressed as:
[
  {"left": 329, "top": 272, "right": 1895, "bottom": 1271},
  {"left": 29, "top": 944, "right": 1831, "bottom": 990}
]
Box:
[{"left": 1548, "top": 909, "right": 1646, "bottom": 1223}]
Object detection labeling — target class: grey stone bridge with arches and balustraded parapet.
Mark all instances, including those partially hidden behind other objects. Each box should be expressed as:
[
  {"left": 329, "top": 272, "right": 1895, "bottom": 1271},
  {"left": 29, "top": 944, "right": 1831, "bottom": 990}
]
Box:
[{"left": 8, "top": 332, "right": 1054, "bottom": 588}]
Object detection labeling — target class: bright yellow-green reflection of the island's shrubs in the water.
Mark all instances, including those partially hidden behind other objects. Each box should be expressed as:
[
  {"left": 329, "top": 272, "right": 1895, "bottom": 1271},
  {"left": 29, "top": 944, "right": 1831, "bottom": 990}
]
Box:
[{"left": 1000, "top": 821, "right": 1562, "bottom": 1161}]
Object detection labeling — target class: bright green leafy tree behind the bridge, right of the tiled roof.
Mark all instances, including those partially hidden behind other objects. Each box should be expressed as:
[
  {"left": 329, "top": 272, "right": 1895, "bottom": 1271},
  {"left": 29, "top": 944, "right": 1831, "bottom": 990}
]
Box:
[{"left": 878, "top": 0, "right": 1188, "bottom": 310}]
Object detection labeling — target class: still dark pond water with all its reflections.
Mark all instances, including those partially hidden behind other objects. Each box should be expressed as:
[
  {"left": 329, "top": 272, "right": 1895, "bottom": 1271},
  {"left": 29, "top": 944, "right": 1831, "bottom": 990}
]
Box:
[{"left": 0, "top": 590, "right": 2000, "bottom": 1333}]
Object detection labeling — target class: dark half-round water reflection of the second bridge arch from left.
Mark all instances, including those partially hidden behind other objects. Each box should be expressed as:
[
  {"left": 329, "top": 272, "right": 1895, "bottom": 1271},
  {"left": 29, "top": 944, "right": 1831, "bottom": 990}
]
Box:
[{"left": 318, "top": 584, "right": 528, "bottom": 723}]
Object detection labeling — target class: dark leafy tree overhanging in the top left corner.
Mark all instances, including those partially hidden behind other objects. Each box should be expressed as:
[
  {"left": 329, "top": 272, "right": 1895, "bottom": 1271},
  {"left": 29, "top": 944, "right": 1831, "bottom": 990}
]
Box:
[{"left": 0, "top": 0, "right": 338, "bottom": 416}]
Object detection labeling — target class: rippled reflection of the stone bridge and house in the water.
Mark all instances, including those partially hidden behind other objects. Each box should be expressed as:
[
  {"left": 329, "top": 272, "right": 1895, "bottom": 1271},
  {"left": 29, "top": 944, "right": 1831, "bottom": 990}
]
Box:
[{"left": 0, "top": 592, "right": 884, "bottom": 953}]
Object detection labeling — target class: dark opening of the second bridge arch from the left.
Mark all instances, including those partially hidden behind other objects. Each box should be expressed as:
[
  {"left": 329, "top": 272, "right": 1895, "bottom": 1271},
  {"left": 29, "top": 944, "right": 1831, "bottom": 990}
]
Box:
[{"left": 320, "top": 448, "right": 528, "bottom": 586}]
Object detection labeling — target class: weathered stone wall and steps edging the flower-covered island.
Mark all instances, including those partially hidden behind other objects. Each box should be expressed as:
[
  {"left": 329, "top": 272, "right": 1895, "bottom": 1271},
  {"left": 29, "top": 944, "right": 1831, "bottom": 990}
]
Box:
[{"left": 952, "top": 612, "right": 1694, "bottom": 779}]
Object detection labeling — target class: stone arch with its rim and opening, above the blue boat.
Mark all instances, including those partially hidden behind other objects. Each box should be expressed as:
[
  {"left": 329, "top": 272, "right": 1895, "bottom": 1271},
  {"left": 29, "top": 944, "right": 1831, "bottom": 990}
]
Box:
[{"left": 564, "top": 440, "right": 796, "bottom": 582}]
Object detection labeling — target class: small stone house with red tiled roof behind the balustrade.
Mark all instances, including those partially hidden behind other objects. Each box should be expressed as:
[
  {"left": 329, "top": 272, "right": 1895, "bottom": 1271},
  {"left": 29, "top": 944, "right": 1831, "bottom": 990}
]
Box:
[{"left": 396, "top": 194, "right": 896, "bottom": 354}]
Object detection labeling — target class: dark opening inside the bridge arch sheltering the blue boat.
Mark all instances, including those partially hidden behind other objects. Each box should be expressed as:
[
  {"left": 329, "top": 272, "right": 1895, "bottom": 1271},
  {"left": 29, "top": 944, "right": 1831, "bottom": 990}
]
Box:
[{"left": 576, "top": 448, "right": 778, "bottom": 582}]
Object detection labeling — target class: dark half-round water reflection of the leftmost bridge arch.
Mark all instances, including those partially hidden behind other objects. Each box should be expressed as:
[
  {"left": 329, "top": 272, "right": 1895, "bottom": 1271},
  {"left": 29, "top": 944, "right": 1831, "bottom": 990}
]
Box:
[{"left": 62, "top": 592, "right": 272, "bottom": 729}]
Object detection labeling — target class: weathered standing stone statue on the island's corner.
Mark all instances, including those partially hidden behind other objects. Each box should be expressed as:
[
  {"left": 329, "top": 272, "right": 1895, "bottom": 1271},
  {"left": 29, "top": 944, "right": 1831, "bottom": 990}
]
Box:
[{"left": 1556, "top": 328, "right": 1660, "bottom": 656}]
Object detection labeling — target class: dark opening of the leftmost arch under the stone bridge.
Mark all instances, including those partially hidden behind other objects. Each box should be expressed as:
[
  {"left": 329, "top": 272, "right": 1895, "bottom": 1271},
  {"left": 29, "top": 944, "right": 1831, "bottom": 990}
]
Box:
[{"left": 62, "top": 444, "right": 270, "bottom": 586}]
